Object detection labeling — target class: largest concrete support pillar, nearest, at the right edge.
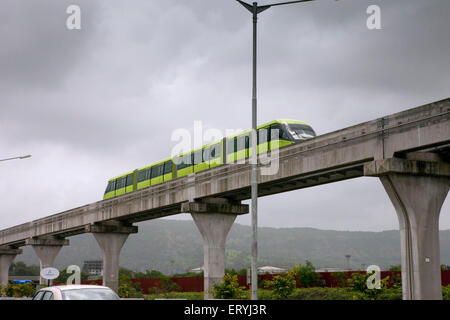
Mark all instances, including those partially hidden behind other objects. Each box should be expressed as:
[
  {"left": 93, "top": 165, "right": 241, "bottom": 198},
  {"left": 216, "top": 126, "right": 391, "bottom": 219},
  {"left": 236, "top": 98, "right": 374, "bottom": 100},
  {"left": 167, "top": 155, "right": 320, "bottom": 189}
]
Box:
[{"left": 366, "top": 158, "right": 450, "bottom": 300}]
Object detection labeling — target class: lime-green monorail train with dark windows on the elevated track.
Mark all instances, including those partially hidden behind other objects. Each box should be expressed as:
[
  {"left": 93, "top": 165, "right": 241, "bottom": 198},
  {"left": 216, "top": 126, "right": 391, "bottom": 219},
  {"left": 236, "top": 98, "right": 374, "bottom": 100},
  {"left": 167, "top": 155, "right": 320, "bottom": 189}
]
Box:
[{"left": 103, "top": 119, "right": 316, "bottom": 199}]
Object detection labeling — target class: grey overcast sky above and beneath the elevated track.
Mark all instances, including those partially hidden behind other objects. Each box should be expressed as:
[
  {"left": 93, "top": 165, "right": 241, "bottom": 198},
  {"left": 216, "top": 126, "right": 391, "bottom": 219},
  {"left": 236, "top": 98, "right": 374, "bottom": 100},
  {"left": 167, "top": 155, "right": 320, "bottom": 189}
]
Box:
[{"left": 0, "top": 0, "right": 450, "bottom": 231}]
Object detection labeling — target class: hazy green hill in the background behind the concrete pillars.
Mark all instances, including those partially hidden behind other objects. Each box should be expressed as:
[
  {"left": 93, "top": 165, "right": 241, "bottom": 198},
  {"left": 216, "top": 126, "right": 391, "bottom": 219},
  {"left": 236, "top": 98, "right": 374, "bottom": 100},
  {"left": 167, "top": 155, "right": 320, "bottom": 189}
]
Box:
[{"left": 16, "top": 219, "right": 450, "bottom": 274}]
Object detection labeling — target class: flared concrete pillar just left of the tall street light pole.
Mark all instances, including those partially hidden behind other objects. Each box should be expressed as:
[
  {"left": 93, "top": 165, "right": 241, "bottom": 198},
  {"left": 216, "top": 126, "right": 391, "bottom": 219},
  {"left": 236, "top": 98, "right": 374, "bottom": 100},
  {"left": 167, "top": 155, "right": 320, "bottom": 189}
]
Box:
[{"left": 182, "top": 199, "right": 248, "bottom": 299}]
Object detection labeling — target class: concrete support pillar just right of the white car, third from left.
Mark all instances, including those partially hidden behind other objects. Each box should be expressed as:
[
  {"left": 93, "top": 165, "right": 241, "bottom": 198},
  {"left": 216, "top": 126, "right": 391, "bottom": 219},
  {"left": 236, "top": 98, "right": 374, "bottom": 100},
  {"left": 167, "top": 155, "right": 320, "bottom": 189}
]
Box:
[{"left": 89, "top": 221, "right": 137, "bottom": 292}]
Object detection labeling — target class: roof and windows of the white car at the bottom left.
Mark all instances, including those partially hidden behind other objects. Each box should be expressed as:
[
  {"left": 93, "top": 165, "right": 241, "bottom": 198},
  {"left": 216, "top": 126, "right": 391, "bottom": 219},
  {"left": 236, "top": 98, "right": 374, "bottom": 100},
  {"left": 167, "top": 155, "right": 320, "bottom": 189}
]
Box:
[{"left": 32, "top": 285, "right": 120, "bottom": 300}]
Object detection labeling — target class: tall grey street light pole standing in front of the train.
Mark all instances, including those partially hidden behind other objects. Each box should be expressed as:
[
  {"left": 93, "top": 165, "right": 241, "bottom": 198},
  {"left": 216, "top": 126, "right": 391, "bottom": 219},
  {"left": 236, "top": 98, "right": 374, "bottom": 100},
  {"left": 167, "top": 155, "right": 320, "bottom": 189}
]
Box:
[{"left": 236, "top": 0, "right": 314, "bottom": 300}]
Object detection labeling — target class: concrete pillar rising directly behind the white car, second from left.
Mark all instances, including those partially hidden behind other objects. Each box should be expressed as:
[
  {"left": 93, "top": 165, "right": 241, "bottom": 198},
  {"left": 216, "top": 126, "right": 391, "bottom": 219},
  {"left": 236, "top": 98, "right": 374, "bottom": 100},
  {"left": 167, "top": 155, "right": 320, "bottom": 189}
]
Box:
[{"left": 26, "top": 238, "right": 69, "bottom": 285}]
